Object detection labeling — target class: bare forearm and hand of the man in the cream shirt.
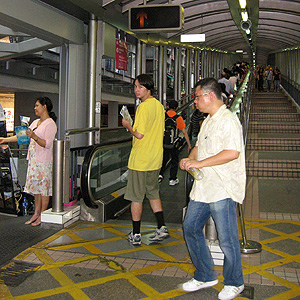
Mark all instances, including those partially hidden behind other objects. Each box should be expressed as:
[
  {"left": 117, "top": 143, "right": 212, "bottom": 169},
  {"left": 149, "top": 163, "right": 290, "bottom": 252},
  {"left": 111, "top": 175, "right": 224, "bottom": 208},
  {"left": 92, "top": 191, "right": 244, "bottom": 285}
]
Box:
[{"left": 182, "top": 150, "right": 240, "bottom": 170}]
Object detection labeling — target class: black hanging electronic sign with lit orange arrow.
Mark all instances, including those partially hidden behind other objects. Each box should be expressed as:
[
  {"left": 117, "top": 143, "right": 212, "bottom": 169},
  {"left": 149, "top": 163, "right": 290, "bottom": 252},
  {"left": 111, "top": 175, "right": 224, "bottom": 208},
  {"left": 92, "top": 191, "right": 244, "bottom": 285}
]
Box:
[{"left": 129, "top": 5, "right": 184, "bottom": 32}]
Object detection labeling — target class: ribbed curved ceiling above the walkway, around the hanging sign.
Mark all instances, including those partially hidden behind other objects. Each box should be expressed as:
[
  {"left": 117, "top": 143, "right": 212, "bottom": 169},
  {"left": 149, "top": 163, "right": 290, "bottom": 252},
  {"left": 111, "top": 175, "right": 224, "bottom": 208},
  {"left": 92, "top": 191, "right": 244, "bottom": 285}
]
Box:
[{"left": 0, "top": 0, "right": 300, "bottom": 72}]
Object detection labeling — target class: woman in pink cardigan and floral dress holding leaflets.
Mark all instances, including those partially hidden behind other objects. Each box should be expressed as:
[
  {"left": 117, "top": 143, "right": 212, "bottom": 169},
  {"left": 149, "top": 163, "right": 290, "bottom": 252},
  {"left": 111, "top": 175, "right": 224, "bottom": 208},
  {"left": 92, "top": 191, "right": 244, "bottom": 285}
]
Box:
[{"left": 0, "top": 97, "right": 57, "bottom": 226}]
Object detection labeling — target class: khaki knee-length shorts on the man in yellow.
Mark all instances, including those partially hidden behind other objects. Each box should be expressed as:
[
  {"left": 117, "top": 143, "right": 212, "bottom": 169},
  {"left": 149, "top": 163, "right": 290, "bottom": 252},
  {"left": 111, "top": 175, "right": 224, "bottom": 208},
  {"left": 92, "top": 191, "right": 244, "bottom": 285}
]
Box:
[{"left": 124, "top": 169, "right": 159, "bottom": 202}]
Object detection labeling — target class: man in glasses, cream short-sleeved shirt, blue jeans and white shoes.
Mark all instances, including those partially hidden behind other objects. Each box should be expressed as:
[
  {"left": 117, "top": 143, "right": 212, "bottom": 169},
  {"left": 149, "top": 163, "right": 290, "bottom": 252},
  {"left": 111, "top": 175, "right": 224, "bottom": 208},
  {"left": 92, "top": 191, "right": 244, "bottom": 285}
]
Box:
[{"left": 179, "top": 78, "right": 246, "bottom": 300}]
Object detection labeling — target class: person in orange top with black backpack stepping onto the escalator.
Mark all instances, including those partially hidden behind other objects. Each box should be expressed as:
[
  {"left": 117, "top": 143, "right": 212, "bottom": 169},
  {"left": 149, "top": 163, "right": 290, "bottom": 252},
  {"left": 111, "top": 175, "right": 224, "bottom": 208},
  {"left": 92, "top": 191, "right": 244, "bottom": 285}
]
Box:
[{"left": 158, "top": 100, "right": 191, "bottom": 186}]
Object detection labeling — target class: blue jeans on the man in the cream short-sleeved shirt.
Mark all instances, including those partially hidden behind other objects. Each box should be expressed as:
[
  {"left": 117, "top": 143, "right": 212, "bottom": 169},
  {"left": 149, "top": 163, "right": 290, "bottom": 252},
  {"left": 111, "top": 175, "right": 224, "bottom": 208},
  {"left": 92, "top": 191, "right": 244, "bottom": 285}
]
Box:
[{"left": 183, "top": 198, "right": 244, "bottom": 286}]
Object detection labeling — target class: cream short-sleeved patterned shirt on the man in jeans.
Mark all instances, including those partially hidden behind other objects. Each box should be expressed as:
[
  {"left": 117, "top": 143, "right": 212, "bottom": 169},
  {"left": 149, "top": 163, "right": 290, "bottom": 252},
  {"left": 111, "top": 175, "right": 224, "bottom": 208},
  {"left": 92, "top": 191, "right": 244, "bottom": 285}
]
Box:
[{"left": 190, "top": 105, "right": 246, "bottom": 203}]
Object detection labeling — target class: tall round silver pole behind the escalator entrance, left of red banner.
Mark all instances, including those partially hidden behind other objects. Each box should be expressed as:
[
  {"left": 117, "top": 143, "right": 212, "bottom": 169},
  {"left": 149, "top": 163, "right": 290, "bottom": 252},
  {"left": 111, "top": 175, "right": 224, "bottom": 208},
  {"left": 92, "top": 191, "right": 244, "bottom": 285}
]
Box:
[{"left": 87, "top": 15, "right": 97, "bottom": 145}]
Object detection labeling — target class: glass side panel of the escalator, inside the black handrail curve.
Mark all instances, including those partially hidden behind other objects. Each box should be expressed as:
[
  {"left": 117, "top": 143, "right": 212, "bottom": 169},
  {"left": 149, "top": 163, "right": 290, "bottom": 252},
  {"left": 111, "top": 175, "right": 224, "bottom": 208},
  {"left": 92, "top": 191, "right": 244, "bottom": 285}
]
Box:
[{"left": 89, "top": 142, "right": 131, "bottom": 202}]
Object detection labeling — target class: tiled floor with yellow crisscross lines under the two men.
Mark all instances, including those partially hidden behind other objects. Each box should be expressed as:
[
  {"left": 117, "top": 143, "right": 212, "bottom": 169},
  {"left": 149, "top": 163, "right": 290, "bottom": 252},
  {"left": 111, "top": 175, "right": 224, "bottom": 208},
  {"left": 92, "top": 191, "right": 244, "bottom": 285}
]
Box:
[{"left": 0, "top": 90, "right": 300, "bottom": 300}]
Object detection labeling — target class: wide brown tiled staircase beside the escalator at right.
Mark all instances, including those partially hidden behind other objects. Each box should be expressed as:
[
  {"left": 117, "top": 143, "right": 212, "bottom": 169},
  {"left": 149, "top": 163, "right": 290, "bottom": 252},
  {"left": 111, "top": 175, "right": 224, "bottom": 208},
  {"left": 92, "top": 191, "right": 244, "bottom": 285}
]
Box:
[{"left": 247, "top": 92, "right": 300, "bottom": 179}]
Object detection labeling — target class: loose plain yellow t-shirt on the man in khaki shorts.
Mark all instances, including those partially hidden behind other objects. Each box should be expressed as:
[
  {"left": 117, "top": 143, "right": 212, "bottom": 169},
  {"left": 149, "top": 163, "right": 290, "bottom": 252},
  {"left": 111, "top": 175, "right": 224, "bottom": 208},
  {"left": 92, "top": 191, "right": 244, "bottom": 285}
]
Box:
[{"left": 128, "top": 97, "right": 165, "bottom": 171}]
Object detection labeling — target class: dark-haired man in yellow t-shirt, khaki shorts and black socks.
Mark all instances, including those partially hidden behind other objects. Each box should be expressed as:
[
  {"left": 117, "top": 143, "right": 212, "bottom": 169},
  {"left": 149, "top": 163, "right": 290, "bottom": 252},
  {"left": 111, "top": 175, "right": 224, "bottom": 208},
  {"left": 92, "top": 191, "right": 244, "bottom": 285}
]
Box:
[{"left": 122, "top": 74, "right": 169, "bottom": 245}]
